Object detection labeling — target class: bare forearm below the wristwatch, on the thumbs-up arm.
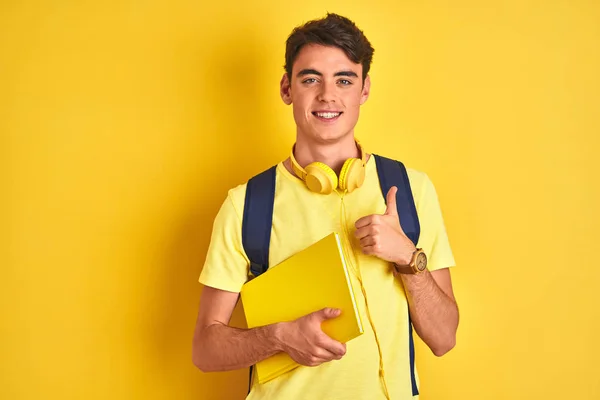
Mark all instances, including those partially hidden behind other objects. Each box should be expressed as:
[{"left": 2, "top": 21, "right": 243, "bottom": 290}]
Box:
[{"left": 398, "top": 270, "right": 459, "bottom": 356}]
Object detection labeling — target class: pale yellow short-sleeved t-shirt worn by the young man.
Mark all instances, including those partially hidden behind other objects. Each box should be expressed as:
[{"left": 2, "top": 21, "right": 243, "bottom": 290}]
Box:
[{"left": 200, "top": 156, "right": 454, "bottom": 400}]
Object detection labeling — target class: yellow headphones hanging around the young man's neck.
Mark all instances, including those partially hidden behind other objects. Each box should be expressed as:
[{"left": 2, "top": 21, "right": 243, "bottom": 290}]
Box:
[{"left": 290, "top": 142, "right": 366, "bottom": 194}]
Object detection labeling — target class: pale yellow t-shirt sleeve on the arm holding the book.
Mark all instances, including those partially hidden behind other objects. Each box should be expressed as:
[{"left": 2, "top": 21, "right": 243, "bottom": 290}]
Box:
[{"left": 199, "top": 191, "right": 249, "bottom": 293}]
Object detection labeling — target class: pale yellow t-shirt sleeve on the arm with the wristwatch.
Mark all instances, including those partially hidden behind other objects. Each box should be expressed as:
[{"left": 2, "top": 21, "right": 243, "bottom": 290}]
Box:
[{"left": 417, "top": 173, "right": 456, "bottom": 271}]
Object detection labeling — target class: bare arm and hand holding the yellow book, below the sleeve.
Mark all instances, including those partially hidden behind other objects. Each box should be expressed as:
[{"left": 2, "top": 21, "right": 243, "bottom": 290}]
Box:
[{"left": 192, "top": 286, "right": 346, "bottom": 372}]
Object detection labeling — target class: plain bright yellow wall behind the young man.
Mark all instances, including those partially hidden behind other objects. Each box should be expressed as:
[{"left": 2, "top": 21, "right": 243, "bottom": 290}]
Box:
[{"left": 0, "top": 0, "right": 600, "bottom": 400}]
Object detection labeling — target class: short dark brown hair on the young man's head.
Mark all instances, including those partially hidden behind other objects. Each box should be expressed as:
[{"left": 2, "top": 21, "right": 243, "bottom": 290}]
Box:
[{"left": 285, "top": 13, "right": 375, "bottom": 82}]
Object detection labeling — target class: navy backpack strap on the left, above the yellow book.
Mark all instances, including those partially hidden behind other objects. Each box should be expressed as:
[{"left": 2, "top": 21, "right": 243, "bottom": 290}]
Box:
[{"left": 242, "top": 166, "right": 276, "bottom": 277}]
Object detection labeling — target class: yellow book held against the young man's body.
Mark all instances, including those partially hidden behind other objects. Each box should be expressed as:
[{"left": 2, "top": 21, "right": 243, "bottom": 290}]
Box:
[{"left": 241, "top": 233, "right": 363, "bottom": 383}]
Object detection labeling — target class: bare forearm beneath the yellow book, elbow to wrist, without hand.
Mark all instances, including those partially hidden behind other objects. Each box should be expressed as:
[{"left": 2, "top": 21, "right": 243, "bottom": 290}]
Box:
[{"left": 193, "top": 323, "right": 282, "bottom": 372}]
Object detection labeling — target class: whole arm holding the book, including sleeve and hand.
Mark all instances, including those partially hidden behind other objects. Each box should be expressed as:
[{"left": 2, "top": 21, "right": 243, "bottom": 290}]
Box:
[{"left": 192, "top": 191, "right": 346, "bottom": 372}]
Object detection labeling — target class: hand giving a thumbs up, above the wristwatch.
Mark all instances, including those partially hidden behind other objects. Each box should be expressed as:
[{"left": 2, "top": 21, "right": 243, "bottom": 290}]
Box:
[{"left": 354, "top": 186, "right": 416, "bottom": 265}]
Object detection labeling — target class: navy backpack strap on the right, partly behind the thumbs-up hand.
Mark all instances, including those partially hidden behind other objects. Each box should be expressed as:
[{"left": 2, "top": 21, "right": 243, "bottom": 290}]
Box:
[{"left": 373, "top": 154, "right": 421, "bottom": 396}]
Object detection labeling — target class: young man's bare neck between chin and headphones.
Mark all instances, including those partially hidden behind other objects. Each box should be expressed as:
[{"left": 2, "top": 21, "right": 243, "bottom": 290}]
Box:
[{"left": 294, "top": 135, "right": 360, "bottom": 175}]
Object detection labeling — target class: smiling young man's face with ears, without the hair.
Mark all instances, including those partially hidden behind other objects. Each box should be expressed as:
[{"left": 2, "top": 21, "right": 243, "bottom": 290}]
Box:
[{"left": 280, "top": 44, "right": 370, "bottom": 143}]
